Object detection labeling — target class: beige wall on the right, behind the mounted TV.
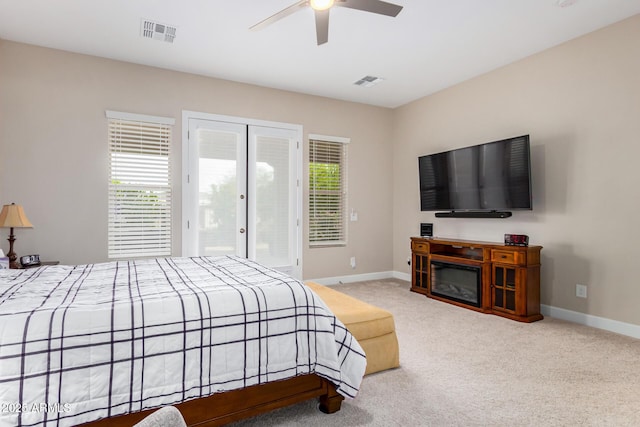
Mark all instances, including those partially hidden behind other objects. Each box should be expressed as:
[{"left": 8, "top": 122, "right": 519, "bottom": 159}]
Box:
[{"left": 393, "top": 15, "right": 640, "bottom": 325}]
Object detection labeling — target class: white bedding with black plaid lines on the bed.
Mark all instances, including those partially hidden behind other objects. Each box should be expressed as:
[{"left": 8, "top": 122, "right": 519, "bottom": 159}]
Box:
[{"left": 0, "top": 257, "right": 366, "bottom": 426}]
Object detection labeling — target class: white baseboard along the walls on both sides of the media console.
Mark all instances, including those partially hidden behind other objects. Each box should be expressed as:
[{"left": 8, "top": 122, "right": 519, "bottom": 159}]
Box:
[{"left": 309, "top": 271, "right": 640, "bottom": 339}]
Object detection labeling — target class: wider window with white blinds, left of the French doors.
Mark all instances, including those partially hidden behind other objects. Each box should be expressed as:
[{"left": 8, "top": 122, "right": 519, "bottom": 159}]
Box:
[{"left": 107, "top": 111, "right": 174, "bottom": 258}]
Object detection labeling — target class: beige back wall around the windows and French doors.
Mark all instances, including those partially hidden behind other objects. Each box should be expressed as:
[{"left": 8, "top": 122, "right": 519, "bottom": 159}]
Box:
[{"left": 0, "top": 40, "right": 393, "bottom": 278}]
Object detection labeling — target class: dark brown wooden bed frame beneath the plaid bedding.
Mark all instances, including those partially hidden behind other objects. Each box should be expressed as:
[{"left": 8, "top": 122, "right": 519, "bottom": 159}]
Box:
[{"left": 82, "top": 374, "right": 344, "bottom": 427}]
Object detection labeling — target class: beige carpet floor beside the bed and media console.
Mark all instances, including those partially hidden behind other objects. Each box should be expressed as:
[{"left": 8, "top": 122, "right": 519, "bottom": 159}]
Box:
[{"left": 233, "top": 279, "right": 640, "bottom": 427}]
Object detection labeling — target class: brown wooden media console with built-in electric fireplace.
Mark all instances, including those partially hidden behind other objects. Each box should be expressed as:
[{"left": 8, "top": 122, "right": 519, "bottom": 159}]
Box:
[{"left": 411, "top": 237, "right": 543, "bottom": 322}]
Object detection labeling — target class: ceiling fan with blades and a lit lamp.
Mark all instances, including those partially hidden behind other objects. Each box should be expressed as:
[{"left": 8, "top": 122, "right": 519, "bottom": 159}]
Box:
[{"left": 249, "top": 0, "right": 402, "bottom": 46}]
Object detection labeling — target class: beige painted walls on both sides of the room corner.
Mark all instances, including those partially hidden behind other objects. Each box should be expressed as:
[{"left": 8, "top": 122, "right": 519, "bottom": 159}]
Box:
[{"left": 0, "top": 16, "right": 640, "bottom": 325}]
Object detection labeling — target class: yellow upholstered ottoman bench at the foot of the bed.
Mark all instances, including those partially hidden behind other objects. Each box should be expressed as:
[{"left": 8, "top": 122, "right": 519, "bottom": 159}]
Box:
[{"left": 305, "top": 282, "right": 400, "bottom": 375}]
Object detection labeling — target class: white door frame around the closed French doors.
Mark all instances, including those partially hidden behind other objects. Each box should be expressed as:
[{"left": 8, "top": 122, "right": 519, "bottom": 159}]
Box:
[{"left": 180, "top": 110, "right": 303, "bottom": 280}]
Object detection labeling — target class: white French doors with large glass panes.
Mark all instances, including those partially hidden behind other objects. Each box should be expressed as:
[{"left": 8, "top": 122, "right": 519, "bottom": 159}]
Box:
[{"left": 182, "top": 115, "right": 302, "bottom": 278}]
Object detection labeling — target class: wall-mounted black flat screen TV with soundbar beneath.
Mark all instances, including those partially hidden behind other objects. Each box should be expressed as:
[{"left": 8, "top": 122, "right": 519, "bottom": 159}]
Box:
[{"left": 418, "top": 135, "right": 531, "bottom": 217}]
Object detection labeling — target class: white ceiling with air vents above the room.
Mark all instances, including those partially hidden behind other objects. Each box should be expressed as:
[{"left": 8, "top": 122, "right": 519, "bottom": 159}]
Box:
[{"left": 0, "top": 0, "right": 640, "bottom": 107}]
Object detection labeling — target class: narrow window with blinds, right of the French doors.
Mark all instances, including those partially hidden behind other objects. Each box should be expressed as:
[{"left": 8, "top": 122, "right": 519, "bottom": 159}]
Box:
[{"left": 309, "top": 135, "right": 349, "bottom": 246}]
